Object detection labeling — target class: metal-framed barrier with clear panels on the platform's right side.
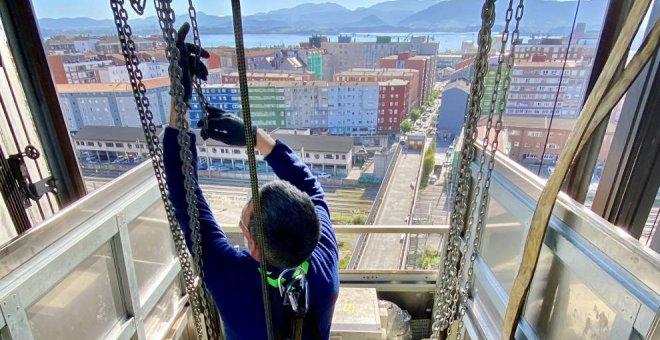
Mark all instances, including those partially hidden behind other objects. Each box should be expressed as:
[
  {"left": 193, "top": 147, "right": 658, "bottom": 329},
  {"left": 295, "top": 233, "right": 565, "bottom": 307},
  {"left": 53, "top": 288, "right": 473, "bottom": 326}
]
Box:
[{"left": 466, "top": 144, "right": 660, "bottom": 339}]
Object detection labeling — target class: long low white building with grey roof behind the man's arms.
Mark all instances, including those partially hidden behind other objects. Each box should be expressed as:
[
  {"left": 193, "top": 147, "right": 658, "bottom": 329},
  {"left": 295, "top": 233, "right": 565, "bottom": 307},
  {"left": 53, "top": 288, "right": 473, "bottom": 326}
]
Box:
[{"left": 73, "top": 126, "right": 353, "bottom": 177}]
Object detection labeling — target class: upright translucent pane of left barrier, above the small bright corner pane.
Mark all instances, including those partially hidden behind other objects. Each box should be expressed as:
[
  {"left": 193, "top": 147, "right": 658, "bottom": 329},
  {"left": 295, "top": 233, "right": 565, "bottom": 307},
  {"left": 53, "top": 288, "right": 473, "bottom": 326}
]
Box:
[{"left": 128, "top": 200, "right": 175, "bottom": 301}]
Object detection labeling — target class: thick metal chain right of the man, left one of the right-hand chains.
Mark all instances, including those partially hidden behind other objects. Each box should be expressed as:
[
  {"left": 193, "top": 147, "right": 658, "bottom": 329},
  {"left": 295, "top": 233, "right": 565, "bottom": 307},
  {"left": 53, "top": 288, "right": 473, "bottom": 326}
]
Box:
[{"left": 432, "top": 0, "right": 495, "bottom": 339}]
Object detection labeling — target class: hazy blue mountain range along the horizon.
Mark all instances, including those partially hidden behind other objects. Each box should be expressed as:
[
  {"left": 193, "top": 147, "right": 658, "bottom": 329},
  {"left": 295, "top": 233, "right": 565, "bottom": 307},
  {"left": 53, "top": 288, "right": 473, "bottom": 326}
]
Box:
[{"left": 39, "top": 0, "right": 607, "bottom": 37}]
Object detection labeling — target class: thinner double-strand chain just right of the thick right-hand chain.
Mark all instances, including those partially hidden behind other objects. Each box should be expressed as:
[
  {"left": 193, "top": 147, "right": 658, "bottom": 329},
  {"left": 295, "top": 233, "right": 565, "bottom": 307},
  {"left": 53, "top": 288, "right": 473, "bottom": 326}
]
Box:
[{"left": 456, "top": 0, "right": 524, "bottom": 340}]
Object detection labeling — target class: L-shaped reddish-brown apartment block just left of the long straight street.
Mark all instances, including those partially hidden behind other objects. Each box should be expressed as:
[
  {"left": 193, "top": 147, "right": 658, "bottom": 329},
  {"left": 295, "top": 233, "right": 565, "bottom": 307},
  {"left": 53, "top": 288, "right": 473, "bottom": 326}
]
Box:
[{"left": 378, "top": 51, "right": 435, "bottom": 104}]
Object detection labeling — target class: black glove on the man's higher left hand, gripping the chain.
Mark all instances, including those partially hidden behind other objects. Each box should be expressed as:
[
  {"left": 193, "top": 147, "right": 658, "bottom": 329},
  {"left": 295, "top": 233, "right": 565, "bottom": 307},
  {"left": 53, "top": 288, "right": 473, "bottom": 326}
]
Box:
[{"left": 176, "top": 22, "right": 210, "bottom": 105}]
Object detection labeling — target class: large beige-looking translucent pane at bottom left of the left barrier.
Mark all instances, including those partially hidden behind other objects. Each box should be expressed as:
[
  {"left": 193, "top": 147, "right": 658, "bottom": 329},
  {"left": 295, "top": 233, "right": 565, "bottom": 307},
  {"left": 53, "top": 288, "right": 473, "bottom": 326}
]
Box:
[{"left": 27, "top": 244, "right": 126, "bottom": 340}]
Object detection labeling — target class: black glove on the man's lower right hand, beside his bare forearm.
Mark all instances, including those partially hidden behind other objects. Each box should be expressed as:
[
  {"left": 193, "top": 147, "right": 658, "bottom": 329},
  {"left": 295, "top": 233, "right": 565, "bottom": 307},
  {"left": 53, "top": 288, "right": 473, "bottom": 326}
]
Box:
[{"left": 197, "top": 105, "right": 257, "bottom": 146}]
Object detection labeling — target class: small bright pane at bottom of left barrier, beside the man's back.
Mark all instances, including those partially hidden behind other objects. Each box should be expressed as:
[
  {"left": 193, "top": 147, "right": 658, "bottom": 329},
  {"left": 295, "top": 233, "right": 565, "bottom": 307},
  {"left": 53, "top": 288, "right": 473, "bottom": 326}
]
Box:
[{"left": 144, "top": 280, "right": 182, "bottom": 339}]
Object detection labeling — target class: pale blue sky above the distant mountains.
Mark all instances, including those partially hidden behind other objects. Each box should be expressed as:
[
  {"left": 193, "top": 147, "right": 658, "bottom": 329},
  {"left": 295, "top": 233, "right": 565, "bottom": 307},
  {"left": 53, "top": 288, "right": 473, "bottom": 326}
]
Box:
[{"left": 32, "top": 0, "right": 385, "bottom": 19}]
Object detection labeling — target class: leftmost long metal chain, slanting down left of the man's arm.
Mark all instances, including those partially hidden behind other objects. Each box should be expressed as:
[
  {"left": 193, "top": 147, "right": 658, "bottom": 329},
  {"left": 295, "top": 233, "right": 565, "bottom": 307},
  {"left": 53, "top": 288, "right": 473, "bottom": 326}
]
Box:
[{"left": 110, "top": 0, "right": 214, "bottom": 339}]
